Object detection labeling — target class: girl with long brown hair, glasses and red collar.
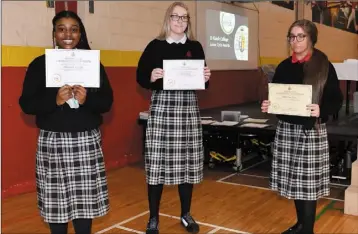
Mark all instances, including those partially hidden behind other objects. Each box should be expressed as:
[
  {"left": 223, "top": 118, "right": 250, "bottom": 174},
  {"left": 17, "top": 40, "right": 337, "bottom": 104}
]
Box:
[{"left": 261, "top": 19, "right": 343, "bottom": 234}]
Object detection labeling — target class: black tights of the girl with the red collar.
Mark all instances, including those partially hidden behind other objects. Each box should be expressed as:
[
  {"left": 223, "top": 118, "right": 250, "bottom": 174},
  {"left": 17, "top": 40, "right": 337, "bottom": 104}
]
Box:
[{"left": 295, "top": 200, "right": 317, "bottom": 234}]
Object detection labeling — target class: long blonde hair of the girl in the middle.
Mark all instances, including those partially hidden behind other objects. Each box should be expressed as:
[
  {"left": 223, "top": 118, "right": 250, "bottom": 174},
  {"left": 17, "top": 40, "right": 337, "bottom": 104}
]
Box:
[{"left": 157, "top": 2, "right": 195, "bottom": 41}]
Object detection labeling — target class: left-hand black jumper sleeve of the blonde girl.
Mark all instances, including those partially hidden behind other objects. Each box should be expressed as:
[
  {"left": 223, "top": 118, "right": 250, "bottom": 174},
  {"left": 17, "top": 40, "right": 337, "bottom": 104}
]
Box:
[{"left": 137, "top": 41, "right": 161, "bottom": 89}]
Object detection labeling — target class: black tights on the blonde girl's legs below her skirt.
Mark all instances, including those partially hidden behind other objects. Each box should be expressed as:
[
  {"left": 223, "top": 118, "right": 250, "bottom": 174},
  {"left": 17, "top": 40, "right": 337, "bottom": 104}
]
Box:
[{"left": 148, "top": 184, "right": 193, "bottom": 218}]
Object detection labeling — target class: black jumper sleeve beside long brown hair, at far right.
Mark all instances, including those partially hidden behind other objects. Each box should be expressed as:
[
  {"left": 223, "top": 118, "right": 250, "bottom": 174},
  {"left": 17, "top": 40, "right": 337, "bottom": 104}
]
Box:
[{"left": 320, "top": 63, "right": 343, "bottom": 117}]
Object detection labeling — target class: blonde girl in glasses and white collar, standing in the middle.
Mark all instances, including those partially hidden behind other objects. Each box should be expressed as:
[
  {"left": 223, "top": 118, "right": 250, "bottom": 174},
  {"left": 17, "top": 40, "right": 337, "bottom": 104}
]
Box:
[{"left": 137, "top": 2, "right": 210, "bottom": 233}]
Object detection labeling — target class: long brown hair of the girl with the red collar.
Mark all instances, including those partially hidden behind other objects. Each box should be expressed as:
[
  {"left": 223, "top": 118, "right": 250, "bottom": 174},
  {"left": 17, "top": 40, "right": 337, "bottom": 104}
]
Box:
[{"left": 287, "top": 19, "right": 329, "bottom": 104}]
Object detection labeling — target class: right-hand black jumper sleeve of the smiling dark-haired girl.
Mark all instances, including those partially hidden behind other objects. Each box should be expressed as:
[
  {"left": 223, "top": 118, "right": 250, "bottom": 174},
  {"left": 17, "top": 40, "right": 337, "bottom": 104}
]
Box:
[{"left": 83, "top": 64, "right": 113, "bottom": 113}]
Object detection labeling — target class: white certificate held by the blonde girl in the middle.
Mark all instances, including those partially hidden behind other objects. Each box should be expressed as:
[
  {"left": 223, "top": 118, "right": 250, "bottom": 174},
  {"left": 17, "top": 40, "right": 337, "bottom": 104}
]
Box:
[{"left": 163, "top": 60, "right": 205, "bottom": 90}]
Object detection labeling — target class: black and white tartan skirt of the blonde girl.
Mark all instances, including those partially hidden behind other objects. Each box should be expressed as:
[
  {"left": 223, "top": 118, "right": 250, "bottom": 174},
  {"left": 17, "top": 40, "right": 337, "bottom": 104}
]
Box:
[{"left": 145, "top": 90, "right": 204, "bottom": 185}]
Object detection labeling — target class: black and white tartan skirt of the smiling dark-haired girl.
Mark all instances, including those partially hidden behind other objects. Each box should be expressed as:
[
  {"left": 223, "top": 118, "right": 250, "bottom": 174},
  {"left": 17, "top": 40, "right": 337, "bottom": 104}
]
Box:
[{"left": 36, "top": 129, "right": 109, "bottom": 223}]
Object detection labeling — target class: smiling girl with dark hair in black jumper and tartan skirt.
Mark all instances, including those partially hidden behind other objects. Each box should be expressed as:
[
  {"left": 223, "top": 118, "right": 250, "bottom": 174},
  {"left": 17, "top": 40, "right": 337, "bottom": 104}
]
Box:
[{"left": 19, "top": 11, "right": 113, "bottom": 234}]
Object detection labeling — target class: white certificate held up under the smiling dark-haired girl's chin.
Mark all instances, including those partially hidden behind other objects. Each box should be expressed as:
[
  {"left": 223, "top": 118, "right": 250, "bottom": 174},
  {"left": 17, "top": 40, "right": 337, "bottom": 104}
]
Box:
[{"left": 46, "top": 49, "right": 100, "bottom": 88}]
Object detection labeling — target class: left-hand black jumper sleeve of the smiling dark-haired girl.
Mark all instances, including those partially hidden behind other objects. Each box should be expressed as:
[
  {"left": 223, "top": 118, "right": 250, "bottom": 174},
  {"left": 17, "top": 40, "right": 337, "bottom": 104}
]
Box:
[{"left": 19, "top": 56, "right": 57, "bottom": 115}]
